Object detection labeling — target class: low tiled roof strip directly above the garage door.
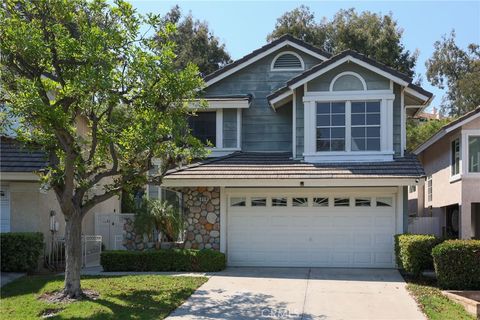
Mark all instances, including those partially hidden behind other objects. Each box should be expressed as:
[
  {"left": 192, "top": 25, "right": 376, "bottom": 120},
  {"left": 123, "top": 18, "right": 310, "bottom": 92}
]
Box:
[{"left": 166, "top": 152, "right": 425, "bottom": 179}]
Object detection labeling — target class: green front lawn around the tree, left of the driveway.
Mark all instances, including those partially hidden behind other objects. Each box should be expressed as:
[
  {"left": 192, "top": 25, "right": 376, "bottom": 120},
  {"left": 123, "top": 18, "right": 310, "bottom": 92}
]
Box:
[{"left": 0, "top": 275, "right": 207, "bottom": 319}]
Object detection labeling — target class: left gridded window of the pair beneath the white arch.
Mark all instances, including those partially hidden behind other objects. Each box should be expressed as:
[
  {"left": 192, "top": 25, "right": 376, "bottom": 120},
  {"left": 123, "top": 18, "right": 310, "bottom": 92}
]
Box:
[{"left": 317, "top": 102, "right": 345, "bottom": 151}]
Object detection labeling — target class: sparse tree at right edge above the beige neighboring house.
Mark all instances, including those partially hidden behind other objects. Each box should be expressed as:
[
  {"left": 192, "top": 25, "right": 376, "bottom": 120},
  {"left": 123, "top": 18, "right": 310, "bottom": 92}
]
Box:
[{"left": 425, "top": 30, "right": 480, "bottom": 116}]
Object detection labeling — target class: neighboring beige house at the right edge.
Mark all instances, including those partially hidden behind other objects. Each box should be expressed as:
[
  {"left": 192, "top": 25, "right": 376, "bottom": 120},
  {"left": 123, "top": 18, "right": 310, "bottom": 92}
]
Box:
[{"left": 408, "top": 107, "right": 480, "bottom": 239}]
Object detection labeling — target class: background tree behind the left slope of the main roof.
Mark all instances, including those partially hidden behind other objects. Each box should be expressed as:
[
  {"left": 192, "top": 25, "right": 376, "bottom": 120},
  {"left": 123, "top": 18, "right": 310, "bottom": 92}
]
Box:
[{"left": 159, "top": 5, "right": 232, "bottom": 75}]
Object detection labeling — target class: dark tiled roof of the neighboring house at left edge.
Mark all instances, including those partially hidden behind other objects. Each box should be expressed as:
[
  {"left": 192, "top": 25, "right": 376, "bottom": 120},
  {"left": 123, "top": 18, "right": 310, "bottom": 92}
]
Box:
[{"left": 0, "top": 136, "right": 47, "bottom": 172}]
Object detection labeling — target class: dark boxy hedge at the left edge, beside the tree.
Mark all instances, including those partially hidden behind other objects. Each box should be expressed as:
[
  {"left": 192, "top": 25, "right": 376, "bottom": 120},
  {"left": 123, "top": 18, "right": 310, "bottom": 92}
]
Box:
[{"left": 0, "top": 232, "right": 43, "bottom": 272}]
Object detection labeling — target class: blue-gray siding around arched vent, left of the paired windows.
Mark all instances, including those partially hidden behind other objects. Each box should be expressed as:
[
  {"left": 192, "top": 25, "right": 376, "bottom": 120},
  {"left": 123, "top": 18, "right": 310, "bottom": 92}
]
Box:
[{"left": 205, "top": 48, "right": 321, "bottom": 151}]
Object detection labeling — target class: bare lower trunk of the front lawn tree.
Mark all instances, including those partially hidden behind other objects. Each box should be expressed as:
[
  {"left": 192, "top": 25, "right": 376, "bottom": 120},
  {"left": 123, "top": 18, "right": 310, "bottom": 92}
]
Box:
[{"left": 63, "top": 213, "right": 83, "bottom": 299}]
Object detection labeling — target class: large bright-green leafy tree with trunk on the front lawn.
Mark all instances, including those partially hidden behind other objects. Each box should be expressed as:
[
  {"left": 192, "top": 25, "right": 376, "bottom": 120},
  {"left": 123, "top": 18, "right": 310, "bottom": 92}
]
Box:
[{"left": 0, "top": 0, "right": 204, "bottom": 298}]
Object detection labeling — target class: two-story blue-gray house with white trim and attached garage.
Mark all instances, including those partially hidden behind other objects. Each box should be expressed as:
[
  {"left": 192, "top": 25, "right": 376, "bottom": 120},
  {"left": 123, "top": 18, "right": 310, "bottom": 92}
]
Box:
[{"left": 163, "top": 36, "right": 432, "bottom": 268}]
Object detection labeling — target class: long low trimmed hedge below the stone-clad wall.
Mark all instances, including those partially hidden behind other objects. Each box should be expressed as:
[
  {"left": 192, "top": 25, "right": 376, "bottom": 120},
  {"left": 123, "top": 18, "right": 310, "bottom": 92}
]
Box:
[{"left": 100, "top": 249, "right": 226, "bottom": 272}]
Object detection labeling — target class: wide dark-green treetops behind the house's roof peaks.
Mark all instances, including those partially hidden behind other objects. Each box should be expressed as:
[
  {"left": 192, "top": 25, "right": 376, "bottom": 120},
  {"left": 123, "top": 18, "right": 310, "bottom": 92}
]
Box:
[{"left": 267, "top": 5, "right": 418, "bottom": 76}]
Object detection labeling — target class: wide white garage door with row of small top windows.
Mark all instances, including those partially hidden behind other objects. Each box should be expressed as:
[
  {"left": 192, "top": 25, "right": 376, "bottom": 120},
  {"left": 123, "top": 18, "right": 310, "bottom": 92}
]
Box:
[{"left": 227, "top": 192, "right": 395, "bottom": 268}]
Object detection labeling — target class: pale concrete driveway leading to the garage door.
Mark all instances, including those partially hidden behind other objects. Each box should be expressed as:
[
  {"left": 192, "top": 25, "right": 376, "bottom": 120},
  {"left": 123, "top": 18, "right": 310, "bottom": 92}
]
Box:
[{"left": 167, "top": 268, "right": 425, "bottom": 320}]
